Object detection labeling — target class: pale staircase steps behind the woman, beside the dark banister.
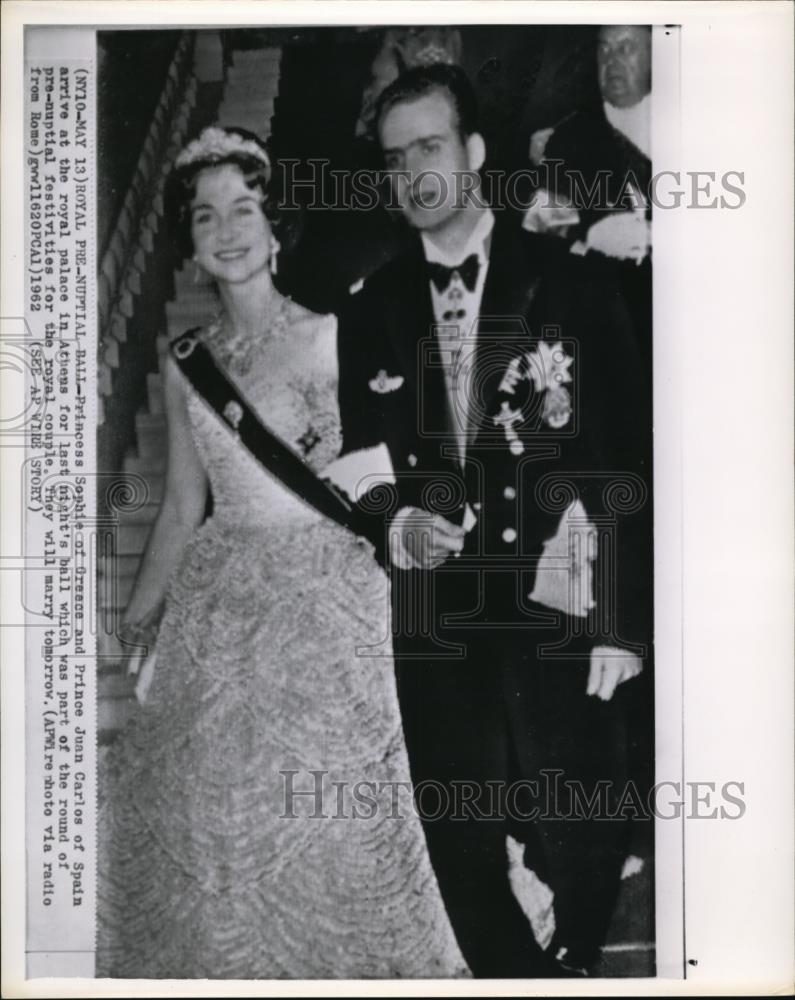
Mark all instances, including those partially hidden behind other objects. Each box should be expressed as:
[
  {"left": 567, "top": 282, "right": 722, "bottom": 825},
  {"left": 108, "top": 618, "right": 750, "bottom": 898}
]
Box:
[{"left": 97, "top": 48, "right": 281, "bottom": 745}]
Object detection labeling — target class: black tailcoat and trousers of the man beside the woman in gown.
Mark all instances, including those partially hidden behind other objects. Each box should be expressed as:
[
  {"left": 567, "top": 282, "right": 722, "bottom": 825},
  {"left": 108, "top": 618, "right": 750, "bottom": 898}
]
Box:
[{"left": 339, "top": 213, "right": 651, "bottom": 976}]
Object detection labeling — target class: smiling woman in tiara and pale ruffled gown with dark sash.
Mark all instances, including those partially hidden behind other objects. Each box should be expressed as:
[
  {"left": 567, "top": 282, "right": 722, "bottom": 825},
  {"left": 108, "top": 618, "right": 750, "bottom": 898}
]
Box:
[{"left": 97, "top": 128, "right": 466, "bottom": 979}]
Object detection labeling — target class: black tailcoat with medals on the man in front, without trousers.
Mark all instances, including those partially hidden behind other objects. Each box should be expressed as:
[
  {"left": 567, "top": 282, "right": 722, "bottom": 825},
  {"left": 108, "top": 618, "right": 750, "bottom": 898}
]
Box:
[{"left": 340, "top": 212, "right": 651, "bottom": 655}]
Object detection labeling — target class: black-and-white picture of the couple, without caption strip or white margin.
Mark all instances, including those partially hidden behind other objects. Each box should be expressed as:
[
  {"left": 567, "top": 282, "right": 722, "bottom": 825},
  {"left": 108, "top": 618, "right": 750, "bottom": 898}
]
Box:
[{"left": 90, "top": 25, "right": 655, "bottom": 979}]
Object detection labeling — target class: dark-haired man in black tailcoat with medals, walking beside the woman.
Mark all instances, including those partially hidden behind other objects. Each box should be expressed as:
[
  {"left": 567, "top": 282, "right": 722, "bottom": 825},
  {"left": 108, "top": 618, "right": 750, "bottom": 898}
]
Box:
[{"left": 339, "top": 66, "right": 651, "bottom": 977}]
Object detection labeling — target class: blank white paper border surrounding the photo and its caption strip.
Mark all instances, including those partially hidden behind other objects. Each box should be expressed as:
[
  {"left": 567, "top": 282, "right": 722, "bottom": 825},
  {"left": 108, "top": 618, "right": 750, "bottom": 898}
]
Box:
[{"left": 0, "top": 0, "right": 795, "bottom": 996}]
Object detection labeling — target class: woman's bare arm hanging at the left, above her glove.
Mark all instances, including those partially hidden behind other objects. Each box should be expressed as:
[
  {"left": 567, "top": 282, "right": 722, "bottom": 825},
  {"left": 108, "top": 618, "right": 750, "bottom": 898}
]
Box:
[{"left": 124, "top": 354, "right": 208, "bottom": 625}]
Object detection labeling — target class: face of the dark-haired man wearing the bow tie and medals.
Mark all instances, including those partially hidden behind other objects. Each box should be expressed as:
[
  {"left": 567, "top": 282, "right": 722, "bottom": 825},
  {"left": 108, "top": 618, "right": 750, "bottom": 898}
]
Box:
[{"left": 379, "top": 92, "right": 472, "bottom": 232}]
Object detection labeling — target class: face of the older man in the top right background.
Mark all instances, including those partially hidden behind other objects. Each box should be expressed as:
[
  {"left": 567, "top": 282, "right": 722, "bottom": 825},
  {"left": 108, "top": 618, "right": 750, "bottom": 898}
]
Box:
[{"left": 596, "top": 24, "right": 651, "bottom": 108}]
